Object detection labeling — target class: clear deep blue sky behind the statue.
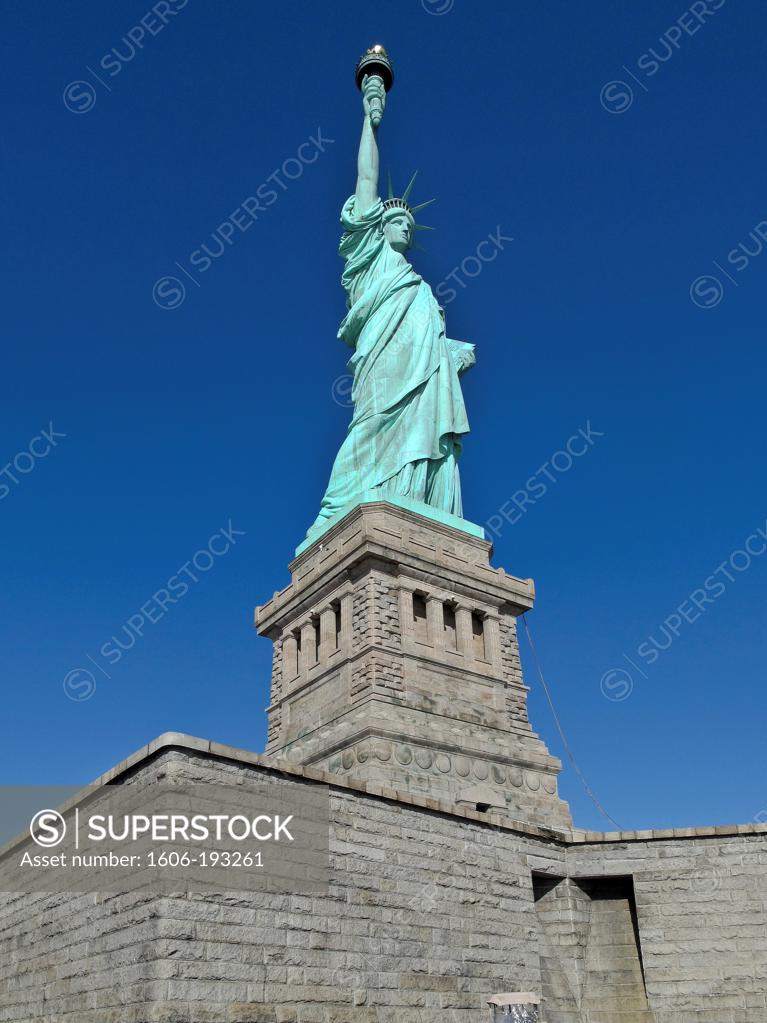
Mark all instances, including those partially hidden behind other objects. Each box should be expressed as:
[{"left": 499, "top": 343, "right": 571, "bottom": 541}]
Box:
[{"left": 0, "top": 0, "right": 767, "bottom": 828}]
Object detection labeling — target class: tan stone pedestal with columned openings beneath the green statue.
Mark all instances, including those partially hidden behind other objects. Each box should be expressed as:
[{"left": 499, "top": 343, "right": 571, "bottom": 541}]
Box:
[{"left": 256, "top": 501, "right": 571, "bottom": 828}]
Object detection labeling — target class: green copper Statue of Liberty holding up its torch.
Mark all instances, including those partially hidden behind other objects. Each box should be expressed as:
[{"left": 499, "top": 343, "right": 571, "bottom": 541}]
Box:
[{"left": 308, "top": 46, "right": 475, "bottom": 539}]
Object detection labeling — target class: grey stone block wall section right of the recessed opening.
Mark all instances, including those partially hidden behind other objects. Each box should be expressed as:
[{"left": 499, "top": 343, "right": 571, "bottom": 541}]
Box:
[{"left": 568, "top": 826, "right": 767, "bottom": 1023}]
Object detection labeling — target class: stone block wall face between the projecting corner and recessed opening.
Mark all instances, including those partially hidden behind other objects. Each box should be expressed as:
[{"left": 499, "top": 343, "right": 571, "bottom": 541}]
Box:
[{"left": 131, "top": 751, "right": 556, "bottom": 1023}]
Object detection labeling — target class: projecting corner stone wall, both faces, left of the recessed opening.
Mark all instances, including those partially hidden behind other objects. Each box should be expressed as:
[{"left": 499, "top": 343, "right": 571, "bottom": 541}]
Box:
[{"left": 0, "top": 740, "right": 561, "bottom": 1023}]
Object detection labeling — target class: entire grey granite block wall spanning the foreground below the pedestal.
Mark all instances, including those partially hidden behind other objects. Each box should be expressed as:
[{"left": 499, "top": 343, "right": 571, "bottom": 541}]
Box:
[{"left": 0, "top": 736, "right": 767, "bottom": 1023}]
